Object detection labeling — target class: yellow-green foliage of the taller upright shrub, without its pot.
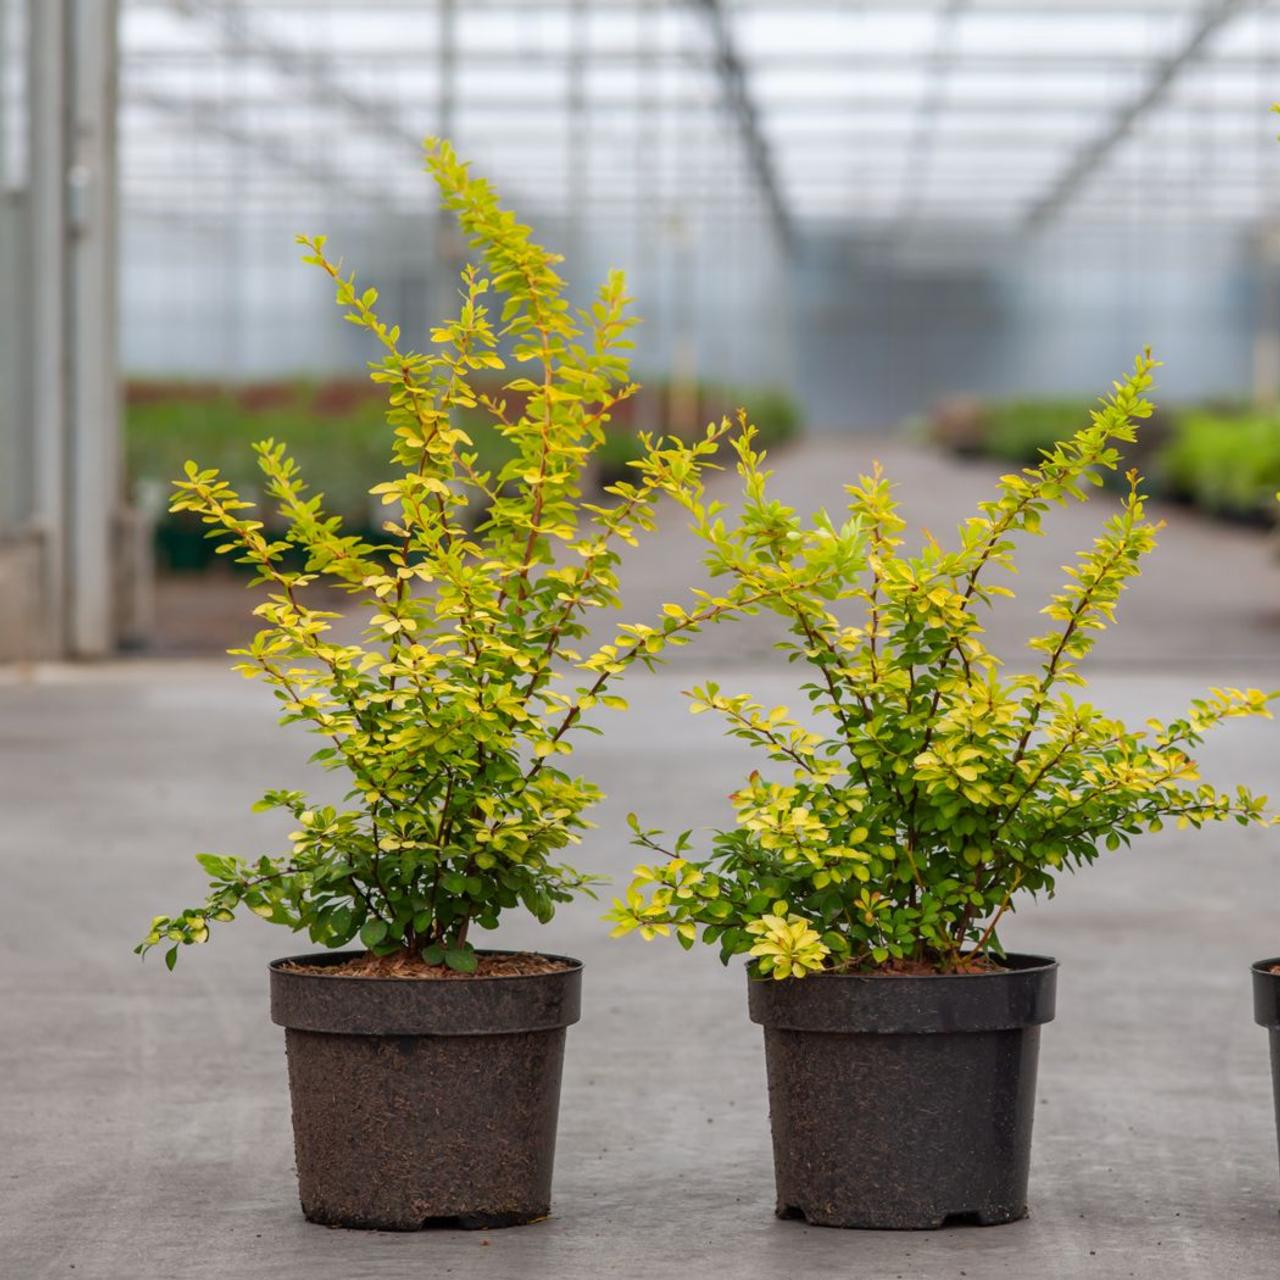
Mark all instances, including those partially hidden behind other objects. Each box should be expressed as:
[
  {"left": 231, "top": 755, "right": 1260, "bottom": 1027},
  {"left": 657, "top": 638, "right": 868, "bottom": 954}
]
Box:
[{"left": 138, "top": 142, "right": 760, "bottom": 970}]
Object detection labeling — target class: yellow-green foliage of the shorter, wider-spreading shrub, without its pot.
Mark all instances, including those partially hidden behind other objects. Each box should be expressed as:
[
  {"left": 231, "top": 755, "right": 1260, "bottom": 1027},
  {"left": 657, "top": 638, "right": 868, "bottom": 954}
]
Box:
[{"left": 609, "top": 355, "right": 1275, "bottom": 978}]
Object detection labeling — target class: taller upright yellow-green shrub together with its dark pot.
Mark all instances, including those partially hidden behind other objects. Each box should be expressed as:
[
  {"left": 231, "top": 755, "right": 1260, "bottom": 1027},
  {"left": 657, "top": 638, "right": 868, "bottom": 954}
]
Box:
[{"left": 137, "top": 142, "right": 750, "bottom": 1230}]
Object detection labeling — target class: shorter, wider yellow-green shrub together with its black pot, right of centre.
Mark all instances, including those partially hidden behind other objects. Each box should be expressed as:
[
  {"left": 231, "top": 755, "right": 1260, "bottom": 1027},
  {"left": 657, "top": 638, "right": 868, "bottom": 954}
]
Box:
[{"left": 609, "top": 355, "right": 1270, "bottom": 1228}]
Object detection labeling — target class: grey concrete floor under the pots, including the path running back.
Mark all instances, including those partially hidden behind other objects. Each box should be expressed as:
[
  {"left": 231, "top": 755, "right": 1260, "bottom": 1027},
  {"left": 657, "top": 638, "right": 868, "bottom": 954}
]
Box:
[{"left": 0, "top": 445, "right": 1280, "bottom": 1280}]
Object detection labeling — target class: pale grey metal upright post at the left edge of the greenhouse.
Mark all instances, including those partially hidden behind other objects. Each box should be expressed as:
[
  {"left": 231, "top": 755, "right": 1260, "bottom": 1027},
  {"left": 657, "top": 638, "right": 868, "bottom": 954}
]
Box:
[{"left": 20, "top": 0, "right": 123, "bottom": 657}]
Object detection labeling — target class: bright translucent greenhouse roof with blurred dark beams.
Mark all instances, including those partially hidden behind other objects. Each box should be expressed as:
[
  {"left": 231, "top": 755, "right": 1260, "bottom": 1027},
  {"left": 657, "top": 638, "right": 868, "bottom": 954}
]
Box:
[{"left": 122, "top": 0, "right": 1280, "bottom": 243}]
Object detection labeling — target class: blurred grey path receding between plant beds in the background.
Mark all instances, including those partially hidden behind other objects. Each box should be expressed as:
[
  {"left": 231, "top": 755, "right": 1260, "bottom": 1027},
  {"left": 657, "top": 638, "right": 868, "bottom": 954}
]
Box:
[{"left": 604, "top": 436, "right": 1280, "bottom": 673}]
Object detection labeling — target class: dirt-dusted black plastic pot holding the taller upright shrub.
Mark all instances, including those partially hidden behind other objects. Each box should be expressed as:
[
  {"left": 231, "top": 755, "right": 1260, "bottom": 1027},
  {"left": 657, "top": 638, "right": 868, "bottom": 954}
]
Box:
[{"left": 270, "top": 952, "right": 582, "bottom": 1231}]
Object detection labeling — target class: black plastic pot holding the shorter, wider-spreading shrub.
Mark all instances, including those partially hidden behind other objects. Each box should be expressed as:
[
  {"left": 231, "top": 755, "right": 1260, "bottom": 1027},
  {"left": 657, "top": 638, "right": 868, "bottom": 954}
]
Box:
[{"left": 749, "top": 955, "right": 1057, "bottom": 1230}]
